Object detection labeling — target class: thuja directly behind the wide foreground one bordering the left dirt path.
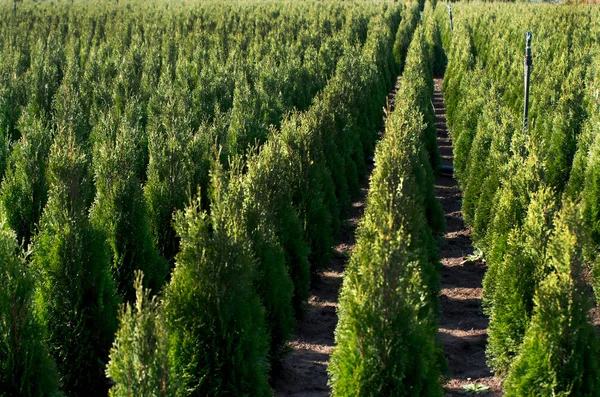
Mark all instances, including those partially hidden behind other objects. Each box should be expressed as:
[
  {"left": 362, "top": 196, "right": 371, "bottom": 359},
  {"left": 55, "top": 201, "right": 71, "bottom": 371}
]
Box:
[{"left": 223, "top": 149, "right": 294, "bottom": 361}]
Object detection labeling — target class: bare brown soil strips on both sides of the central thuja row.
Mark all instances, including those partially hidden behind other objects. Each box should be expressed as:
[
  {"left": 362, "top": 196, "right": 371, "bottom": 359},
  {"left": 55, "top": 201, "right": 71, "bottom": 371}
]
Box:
[{"left": 273, "top": 79, "right": 502, "bottom": 397}]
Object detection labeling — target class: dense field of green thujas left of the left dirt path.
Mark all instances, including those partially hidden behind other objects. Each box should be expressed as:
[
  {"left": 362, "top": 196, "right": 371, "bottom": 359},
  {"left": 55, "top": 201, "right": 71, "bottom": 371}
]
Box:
[{"left": 0, "top": 1, "right": 418, "bottom": 396}]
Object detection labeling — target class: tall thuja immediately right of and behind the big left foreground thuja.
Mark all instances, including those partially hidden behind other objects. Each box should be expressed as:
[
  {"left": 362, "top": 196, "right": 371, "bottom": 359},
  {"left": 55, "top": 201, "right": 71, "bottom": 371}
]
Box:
[{"left": 90, "top": 114, "right": 167, "bottom": 300}]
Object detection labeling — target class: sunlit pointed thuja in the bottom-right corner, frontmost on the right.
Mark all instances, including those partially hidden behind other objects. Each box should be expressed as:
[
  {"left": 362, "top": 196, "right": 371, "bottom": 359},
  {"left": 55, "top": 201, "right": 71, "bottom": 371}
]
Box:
[{"left": 504, "top": 203, "right": 600, "bottom": 397}]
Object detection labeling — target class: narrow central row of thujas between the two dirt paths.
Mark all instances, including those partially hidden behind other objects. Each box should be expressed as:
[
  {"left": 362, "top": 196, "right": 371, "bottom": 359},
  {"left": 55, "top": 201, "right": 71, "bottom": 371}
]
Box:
[{"left": 328, "top": 3, "right": 445, "bottom": 396}]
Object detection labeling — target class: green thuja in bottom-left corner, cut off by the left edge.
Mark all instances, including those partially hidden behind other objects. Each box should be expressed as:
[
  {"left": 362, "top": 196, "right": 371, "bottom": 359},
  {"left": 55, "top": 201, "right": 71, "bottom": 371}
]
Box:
[{"left": 0, "top": 215, "right": 59, "bottom": 397}]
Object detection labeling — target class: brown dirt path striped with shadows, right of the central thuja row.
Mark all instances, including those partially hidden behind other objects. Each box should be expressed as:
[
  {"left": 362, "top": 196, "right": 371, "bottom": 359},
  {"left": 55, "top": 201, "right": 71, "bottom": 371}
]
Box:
[{"left": 433, "top": 78, "right": 502, "bottom": 397}]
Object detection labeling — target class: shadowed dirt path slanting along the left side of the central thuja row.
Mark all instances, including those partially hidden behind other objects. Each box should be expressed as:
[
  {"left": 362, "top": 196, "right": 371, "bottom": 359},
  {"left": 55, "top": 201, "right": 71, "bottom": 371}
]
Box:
[{"left": 273, "top": 78, "right": 398, "bottom": 397}]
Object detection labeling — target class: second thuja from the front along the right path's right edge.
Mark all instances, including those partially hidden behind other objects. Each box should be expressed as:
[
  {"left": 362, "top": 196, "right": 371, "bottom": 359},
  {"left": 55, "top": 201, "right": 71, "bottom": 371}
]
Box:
[{"left": 486, "top": 189, "right": 558, "bottom": 373}]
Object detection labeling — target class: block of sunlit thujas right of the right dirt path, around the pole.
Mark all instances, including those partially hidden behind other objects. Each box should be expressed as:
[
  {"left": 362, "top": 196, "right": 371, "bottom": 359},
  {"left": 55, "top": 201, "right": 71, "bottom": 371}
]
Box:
[{"left": 436, "top": 4, "right": 600, "bottom": 396}]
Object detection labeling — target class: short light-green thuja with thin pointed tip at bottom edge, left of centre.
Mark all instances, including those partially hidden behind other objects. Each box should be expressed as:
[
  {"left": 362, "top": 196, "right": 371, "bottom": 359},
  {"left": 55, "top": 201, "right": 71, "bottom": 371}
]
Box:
[{"left": 106, "top": 271, "right": 178, "bottom": 397}]
